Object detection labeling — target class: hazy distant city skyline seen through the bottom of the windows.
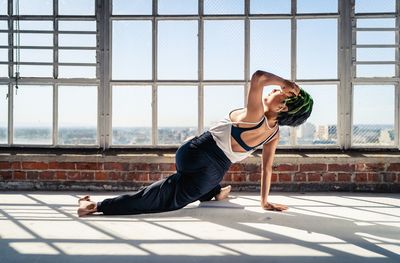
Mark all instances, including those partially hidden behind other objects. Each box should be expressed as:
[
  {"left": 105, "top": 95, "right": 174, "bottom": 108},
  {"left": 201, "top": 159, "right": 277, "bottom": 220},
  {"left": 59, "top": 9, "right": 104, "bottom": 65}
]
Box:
[{"left": 0, "top": 122, "right": 395, "bottom": 145}]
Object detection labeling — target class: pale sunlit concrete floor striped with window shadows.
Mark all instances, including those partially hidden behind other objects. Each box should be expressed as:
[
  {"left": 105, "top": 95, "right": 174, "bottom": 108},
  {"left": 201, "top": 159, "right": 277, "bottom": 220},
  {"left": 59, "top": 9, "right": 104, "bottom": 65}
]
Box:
[{"left": 0, "top": 192, "right": 400, "bottom": 263}]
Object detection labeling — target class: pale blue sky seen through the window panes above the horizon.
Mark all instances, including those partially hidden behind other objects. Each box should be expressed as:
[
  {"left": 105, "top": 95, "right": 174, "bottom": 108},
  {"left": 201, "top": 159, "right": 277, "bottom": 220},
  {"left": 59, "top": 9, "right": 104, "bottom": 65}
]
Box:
[{"left": 0, "top": 0, "right": 395, "bottom": 131}]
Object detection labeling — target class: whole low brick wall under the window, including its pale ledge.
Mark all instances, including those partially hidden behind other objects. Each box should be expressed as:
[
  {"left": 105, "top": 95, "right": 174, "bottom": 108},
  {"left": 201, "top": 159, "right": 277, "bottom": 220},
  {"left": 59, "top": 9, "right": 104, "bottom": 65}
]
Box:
[{"left": 0, "top": 154, "right": 400, "bottom": 192}]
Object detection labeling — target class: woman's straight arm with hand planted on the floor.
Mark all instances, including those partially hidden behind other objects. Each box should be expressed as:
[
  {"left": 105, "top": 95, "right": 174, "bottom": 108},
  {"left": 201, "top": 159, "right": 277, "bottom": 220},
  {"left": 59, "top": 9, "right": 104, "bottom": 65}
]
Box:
[{"left": 261, "top": 134, "right": 288, "bottom": 211}]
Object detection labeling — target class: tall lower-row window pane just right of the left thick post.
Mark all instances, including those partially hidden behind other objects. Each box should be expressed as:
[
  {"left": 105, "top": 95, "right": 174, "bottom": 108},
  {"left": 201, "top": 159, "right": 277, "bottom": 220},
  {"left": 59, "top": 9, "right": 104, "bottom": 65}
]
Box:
[{"left": 112, "top": 86, "right": 152, "bottom": 145}]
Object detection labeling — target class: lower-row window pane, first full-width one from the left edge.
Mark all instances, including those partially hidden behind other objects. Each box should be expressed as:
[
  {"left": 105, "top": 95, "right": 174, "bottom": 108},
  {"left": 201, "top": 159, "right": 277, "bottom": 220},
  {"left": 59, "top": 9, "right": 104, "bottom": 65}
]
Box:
[{"left": 14, "top": 85, "right": 53, "bottom": 144}]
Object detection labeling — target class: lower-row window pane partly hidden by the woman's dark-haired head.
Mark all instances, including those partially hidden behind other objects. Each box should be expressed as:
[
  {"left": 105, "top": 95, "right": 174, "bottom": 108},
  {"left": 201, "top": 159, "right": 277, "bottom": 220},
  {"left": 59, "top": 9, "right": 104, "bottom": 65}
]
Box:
[{"left": 297, "top": 85, "right": 338, "bottom": 145}]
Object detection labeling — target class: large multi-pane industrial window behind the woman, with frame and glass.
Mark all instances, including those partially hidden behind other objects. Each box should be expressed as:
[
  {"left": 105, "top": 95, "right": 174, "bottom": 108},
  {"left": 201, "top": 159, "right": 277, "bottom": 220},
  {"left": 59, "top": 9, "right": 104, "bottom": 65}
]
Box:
[{"left": 0, "top": 0, "right": 400, "bottom": 149}]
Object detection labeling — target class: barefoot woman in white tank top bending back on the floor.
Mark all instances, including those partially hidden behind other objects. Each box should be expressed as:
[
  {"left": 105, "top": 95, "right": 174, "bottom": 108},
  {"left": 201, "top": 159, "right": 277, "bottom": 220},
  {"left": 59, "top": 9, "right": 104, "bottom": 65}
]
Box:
[{"left": 78, "top": 70, "right": 313, "bottom": 216}]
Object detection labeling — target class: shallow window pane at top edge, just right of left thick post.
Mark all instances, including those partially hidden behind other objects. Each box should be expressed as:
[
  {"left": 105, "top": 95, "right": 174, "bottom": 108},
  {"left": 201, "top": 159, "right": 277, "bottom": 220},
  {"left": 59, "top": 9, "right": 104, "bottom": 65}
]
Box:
[{"left": 113, "top": 0, "right": 153, "bottom": 15}]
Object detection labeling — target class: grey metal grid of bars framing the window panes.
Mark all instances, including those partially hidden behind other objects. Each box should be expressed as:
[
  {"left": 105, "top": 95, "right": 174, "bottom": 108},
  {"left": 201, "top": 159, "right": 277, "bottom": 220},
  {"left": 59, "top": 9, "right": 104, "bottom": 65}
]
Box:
[{"left": 0, "top": 0, "right": 400, "bottom": 150}]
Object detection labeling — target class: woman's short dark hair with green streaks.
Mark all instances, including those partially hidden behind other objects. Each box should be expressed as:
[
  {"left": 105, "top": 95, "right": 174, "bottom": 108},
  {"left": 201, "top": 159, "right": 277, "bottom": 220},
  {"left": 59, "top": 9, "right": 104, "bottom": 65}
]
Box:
[{"left": 278, "top": 89, "right": 314, "bottom": 126}]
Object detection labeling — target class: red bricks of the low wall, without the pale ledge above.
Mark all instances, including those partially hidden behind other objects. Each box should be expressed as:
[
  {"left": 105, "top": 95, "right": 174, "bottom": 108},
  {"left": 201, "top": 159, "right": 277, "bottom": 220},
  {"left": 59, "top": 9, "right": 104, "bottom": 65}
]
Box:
[{"left": 0, "top": 158, "right": 400, "bottom": 192}]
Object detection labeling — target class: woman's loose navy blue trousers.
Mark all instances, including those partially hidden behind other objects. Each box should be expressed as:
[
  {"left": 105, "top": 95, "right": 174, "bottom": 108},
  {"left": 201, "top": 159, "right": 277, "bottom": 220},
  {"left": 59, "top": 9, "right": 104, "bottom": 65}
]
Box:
[{"left": 97, "top": 132, "right": 231, "bottom": 215}]
